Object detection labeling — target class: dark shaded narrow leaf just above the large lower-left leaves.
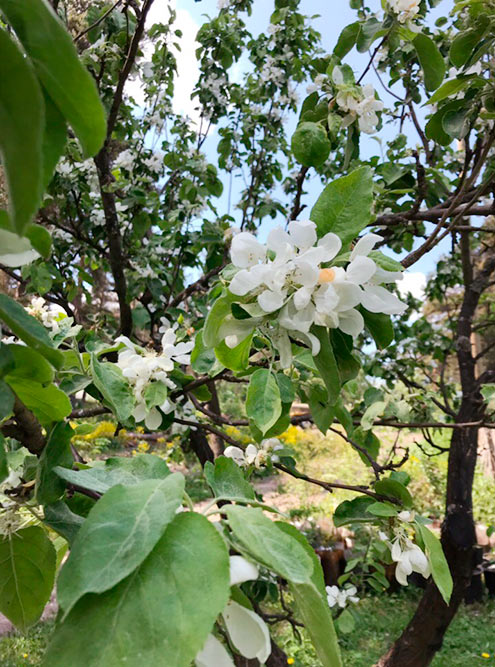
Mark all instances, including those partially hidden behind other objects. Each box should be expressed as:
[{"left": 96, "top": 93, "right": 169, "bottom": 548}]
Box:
[{"left": 36, "top": 422, "right": 74, "bottom": 505}]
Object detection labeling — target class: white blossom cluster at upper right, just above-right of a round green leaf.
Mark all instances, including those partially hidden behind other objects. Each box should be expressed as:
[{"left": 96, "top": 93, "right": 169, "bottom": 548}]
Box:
[{"left": 332, "top": 67, "right": 383, "bottom": 134}]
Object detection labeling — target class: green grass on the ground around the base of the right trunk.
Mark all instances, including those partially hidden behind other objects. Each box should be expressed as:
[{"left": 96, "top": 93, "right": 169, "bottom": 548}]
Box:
[{"left": 279, "top": 589, "right": 495, "bottom": 667}]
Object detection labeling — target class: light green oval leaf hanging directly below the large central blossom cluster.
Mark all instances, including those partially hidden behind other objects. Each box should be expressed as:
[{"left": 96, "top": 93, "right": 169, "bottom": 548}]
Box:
[{"left": 246, "top": 368, "right": 282, "bottom": 434}]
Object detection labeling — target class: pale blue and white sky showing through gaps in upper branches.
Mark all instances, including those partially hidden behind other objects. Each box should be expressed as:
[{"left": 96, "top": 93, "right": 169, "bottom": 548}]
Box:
[{"left": 161, "top": 0, "right": 453, "bottom": 294}]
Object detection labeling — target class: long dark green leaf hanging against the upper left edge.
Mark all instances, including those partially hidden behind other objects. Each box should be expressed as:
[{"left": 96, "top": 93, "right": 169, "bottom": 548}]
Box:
[{"left": 0, "top": 28, "right": 44, "bottom": 234}]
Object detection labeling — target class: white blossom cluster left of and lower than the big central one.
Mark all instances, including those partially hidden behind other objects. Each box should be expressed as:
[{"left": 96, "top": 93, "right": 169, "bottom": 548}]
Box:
[{"left": 116, "top": 329, "right": 194, "bottom": 430}]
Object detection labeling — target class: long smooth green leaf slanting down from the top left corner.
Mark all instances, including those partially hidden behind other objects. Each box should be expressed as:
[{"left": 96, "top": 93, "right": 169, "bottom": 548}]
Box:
[{"left": 0, "top": 0, "right": 107, "bottom": 157}]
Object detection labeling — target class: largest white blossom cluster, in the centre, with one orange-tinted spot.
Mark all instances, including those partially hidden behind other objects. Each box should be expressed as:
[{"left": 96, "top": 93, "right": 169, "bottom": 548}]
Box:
[{"left": 227, "top": 220, "right": 406, "bottom": 366}]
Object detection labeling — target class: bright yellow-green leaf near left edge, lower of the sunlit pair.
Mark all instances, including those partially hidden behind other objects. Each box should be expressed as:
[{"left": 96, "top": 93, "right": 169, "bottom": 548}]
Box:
[{"left": 8, "top": 377, "right": 72, "bottom": 425}]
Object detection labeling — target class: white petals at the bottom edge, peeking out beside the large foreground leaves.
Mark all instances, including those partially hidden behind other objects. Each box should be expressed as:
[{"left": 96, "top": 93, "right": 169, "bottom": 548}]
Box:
[{"left": 194, "top": 556, "right": 271, "bottom": 667}]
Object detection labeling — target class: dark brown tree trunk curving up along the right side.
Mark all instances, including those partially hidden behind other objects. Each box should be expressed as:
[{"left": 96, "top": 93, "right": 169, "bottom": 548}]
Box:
[{"left": 377, "top": 248, "right": 495, "bottom": 667}]
